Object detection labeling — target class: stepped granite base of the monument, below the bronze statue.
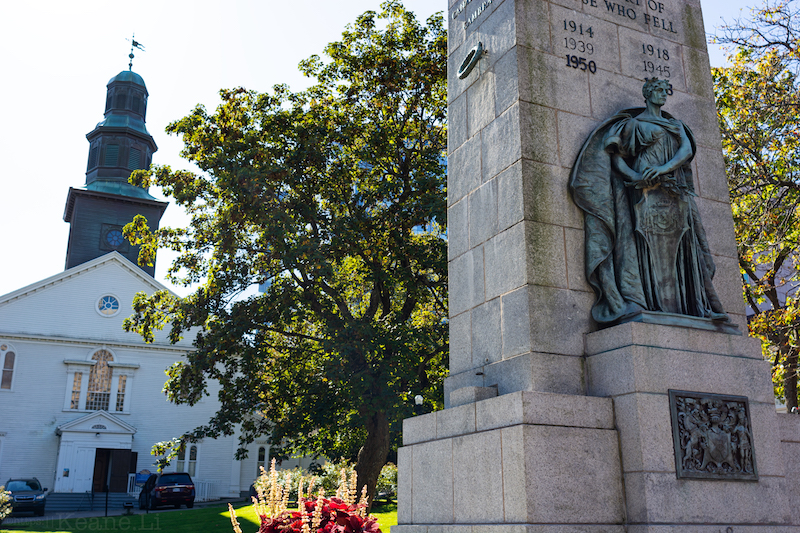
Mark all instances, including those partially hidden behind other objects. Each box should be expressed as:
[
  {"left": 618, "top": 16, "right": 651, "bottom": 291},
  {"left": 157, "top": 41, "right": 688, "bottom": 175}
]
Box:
[{"left": 392, "top": 322, "right": 800, "bottom": 533}]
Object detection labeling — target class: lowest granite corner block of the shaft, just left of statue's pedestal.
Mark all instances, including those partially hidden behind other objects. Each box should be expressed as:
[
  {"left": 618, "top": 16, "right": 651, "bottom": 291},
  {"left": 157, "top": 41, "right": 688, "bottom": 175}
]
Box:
[{"left": 482, "top": 352, "right": 585, "bottom": 395}]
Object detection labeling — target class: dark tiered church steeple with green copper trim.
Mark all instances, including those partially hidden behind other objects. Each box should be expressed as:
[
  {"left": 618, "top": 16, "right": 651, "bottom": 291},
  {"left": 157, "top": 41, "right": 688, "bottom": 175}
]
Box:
[{"left": 64, "top": 70, "right": 167, "bottom": 276}]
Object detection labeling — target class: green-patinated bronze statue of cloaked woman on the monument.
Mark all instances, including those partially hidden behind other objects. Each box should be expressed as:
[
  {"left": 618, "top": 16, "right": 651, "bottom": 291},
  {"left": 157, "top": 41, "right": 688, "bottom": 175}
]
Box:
[{"left": 570, "top": 78, "right": 729, "bottom": 325}]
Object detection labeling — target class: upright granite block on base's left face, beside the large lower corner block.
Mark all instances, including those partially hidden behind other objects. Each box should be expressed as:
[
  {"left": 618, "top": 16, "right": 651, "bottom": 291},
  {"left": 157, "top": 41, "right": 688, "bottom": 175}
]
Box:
[{"left": 453, "top": 431, "right": 504, "bottom": 524}]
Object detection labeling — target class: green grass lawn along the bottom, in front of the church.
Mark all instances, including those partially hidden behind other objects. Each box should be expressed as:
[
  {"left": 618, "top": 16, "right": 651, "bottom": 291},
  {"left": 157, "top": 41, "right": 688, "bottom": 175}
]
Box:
[{"left": 0, "top": 503, "right": 397, "bottom": 533}]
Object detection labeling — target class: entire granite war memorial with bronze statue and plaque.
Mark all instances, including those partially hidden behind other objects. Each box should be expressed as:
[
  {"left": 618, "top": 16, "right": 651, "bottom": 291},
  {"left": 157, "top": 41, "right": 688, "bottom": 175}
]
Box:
[{"left": 392, "top": 0, "right": 800, "bottom": 533}]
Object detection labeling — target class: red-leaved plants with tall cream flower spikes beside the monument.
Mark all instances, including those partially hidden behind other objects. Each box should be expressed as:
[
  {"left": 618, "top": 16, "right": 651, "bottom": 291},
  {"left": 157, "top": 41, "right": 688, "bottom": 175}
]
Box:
[{"left": 228, "top": 459, "right": 381, "bottom": 533}]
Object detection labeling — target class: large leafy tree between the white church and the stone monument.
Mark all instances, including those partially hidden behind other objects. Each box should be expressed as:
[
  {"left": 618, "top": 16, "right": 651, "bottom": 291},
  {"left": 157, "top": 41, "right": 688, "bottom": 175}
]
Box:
[{"left": 126, "top": 0, "right": 448, "bottom": 494}]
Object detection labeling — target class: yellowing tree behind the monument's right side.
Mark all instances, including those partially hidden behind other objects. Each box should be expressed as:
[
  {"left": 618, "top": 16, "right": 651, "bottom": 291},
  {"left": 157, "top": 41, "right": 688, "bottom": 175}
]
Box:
[{"left": 713, "top": 0, "right": 800, "bottom": 409}]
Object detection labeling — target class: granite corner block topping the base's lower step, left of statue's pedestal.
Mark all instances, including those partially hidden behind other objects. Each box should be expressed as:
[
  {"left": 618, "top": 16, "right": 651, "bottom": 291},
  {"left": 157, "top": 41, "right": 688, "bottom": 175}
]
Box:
[{"left": 475, "top": 391, "right": 614, "bottom": 431}]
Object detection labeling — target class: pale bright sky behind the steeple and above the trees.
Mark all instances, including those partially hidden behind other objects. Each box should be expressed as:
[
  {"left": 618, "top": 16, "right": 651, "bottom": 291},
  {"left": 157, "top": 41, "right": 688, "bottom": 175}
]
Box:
[{"left": 0, "top": 0, "right": 753, "bottom": 295}]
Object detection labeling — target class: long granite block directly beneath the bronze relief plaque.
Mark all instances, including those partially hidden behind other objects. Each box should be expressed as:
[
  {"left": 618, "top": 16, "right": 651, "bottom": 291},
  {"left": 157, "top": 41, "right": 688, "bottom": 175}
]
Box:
[{"left": 625, "top": 472, "right": 791, "bottom": 527}]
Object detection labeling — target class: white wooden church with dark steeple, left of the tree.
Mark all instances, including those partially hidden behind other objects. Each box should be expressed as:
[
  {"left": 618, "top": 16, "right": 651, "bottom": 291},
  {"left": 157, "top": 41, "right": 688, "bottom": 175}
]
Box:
[{"left": 0, "top": 71, "right": 282, "bottom": 510}]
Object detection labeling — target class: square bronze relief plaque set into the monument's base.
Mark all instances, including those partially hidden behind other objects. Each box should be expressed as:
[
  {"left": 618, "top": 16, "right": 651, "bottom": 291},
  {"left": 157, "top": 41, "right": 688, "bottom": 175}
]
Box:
[{"left": 669, "top": 390, "right": 758, "bottom": 481}]
